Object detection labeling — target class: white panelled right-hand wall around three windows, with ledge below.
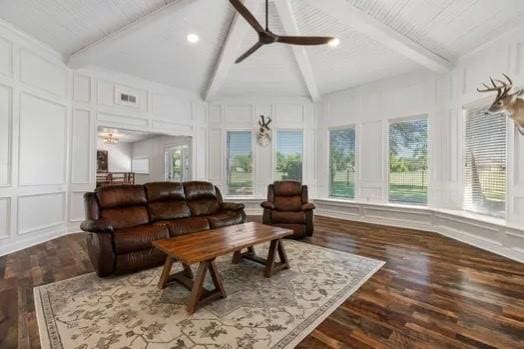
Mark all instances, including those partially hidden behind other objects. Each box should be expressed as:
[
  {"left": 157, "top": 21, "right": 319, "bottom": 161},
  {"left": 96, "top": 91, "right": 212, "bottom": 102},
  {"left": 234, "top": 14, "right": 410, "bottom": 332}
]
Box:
[{"left": 318, "top": 28, "right": 524, "bottom": 261}]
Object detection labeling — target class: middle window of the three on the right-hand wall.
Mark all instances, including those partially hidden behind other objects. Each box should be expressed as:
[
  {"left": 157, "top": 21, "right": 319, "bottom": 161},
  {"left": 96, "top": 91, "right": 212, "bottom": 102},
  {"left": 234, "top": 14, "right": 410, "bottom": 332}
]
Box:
[{"left": 389, "top": 118, "right": 428, "bottom": 205}]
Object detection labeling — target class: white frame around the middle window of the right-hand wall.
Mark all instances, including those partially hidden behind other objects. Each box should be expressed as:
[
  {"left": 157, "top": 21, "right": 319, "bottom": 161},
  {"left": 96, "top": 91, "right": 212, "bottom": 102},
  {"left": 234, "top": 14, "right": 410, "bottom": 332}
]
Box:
[{"left": 384, "top": 113, "right": 432, "bottom": 207}]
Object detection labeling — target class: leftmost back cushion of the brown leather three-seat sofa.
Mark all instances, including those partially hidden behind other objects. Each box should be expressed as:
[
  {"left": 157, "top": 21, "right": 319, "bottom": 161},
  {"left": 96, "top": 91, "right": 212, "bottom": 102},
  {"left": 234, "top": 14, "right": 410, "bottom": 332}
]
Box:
[{"left": 96, "top": 185, "right": 149, "bottom": 229}]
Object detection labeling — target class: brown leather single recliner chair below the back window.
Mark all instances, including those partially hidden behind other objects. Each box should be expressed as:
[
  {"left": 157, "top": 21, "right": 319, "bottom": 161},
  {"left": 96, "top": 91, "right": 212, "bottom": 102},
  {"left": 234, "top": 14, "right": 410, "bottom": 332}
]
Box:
[{"left": 261, "top": 181, "right": 315, "bottom": 238}]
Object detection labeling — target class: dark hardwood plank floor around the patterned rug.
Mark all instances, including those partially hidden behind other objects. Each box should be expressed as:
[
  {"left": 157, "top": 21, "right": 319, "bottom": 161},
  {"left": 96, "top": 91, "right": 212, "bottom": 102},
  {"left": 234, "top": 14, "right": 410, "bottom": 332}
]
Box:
[{"left": 0, "top": 217, "right": 524, "bottom": 349}]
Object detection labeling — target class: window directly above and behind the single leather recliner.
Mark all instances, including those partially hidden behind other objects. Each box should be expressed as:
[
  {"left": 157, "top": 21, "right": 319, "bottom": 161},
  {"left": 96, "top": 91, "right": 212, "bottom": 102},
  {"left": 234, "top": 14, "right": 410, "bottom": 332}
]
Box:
[{"left": 275, "top": 131, "right": 303, "bottom": 182}]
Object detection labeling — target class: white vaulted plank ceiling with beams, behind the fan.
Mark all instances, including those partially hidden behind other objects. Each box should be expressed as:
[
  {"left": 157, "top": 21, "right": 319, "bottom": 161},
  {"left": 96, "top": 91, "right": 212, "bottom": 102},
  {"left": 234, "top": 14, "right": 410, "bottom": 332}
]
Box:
[{"left": 0, "top": 0, "right": 524, "bottom": 99}]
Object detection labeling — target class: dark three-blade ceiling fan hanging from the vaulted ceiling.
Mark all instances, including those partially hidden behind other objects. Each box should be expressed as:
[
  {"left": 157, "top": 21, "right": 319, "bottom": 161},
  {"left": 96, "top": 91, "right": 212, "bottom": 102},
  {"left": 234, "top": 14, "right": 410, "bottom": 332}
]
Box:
[{"left": 229, "top": 0, "right": 336, "bottom": 63}]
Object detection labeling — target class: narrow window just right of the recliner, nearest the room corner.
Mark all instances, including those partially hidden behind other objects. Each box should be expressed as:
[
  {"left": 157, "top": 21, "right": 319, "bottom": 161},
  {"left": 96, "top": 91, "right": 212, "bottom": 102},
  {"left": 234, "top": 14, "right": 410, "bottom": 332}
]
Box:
[{"left": 329, "top": 128, "right": 355, "bottom": 198}]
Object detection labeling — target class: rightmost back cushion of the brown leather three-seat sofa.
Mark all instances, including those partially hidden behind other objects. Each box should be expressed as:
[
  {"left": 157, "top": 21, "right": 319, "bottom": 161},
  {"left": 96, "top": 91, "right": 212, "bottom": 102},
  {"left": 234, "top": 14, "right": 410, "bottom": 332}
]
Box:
[{"left": 184, "top": 181, "right": 220, "bottom": 216}]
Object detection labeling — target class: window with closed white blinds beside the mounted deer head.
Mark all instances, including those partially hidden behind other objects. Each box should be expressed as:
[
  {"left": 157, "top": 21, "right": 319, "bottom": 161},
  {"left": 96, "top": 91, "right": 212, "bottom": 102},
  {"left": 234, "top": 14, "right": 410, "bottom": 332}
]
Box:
[{"left": 464, "top": 109, "right": 507, "bottom": 217}]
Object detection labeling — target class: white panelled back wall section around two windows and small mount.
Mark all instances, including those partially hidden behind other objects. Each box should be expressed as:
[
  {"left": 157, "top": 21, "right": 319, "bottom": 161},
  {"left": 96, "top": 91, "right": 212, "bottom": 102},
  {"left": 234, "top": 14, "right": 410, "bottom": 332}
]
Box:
[{"left": 208, "top": 97, "right": 317, "bottom": 198}]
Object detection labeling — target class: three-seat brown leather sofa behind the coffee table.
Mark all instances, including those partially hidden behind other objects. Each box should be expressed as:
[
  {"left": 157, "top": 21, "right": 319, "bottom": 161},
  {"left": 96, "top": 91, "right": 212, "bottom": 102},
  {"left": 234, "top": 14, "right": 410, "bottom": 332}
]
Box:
[{"left": 81, "top": 181, "right": 246, "bottom": 276}]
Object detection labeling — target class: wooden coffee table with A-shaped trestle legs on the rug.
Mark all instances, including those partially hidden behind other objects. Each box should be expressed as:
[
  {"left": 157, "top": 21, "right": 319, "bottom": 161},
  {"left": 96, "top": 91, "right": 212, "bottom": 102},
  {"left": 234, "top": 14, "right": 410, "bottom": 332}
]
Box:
[{"left": 153, "top": 223, "right": 293, "bottom": 314}]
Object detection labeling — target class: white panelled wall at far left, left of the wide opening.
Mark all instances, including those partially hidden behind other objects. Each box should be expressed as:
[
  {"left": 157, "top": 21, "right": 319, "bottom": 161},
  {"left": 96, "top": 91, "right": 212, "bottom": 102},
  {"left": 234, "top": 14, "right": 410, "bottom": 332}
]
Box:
[{"left": 0, "top": 22, "right": 71, "bottom": 255}]
